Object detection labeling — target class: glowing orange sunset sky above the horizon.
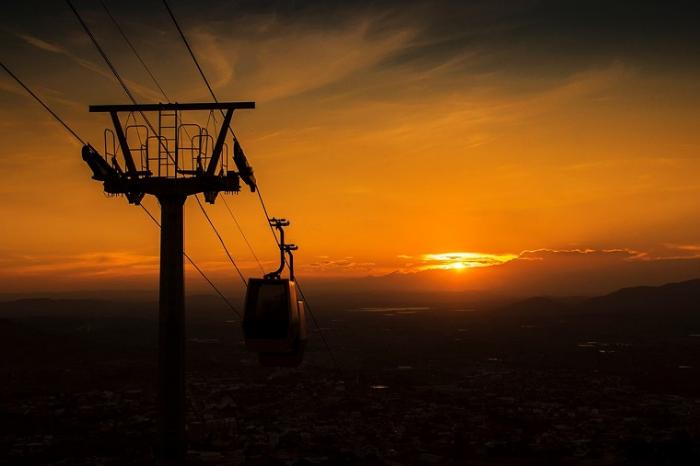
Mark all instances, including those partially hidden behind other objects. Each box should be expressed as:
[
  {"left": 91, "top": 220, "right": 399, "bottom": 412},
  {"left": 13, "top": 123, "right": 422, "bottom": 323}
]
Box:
[{"left": 0, "top": 0, "right": 700, "bottom": 294}]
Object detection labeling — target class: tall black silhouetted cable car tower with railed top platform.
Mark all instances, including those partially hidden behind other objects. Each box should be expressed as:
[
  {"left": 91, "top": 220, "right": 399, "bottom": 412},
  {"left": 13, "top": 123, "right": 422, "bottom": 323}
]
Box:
[{"left": 82, "top": 102, "right": 256, "bottom": 464}]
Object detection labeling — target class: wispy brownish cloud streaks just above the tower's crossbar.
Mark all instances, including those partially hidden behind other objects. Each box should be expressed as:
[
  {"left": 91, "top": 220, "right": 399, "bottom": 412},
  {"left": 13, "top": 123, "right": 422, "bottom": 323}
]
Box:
[{"left": 192, "top": 18, "right": 411, "bottom": 101}]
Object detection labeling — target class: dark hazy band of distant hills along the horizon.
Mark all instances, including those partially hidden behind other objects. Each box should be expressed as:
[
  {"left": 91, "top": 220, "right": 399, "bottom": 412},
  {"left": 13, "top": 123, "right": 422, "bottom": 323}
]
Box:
[{"left": 0, "top": 279, "right": 700, "bottom": 326}]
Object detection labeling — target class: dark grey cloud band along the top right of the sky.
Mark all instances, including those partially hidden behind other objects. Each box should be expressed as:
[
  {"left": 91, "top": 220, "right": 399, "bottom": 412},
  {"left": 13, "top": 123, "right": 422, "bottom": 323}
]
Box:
[{"left": 182, "top": 0, "right": 700, "bottom": 81}]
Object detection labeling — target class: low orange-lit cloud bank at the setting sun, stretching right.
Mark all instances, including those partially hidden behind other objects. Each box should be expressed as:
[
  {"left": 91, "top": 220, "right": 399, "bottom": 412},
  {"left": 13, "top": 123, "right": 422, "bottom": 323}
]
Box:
[{"left": 366, "top": 245, "right": 700, "bottom": 297}]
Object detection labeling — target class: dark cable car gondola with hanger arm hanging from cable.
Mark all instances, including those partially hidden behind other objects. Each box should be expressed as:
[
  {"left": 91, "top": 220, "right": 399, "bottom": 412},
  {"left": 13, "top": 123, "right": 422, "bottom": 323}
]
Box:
[{"left": 243, "top": 219, "right": 307, "bottom": 367}]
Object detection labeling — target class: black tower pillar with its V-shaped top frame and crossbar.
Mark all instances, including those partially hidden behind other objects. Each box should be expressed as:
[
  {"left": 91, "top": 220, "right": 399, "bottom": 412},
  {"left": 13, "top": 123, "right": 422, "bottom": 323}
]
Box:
[{"left": 82, "top": 102, "right": 256, "bottom": 466}]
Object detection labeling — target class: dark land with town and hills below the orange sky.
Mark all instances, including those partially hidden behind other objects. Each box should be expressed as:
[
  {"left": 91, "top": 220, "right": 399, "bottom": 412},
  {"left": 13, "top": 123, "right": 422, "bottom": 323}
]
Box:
[{"left": 0, "top": 281, "right": 700, "bottom": 465}]
